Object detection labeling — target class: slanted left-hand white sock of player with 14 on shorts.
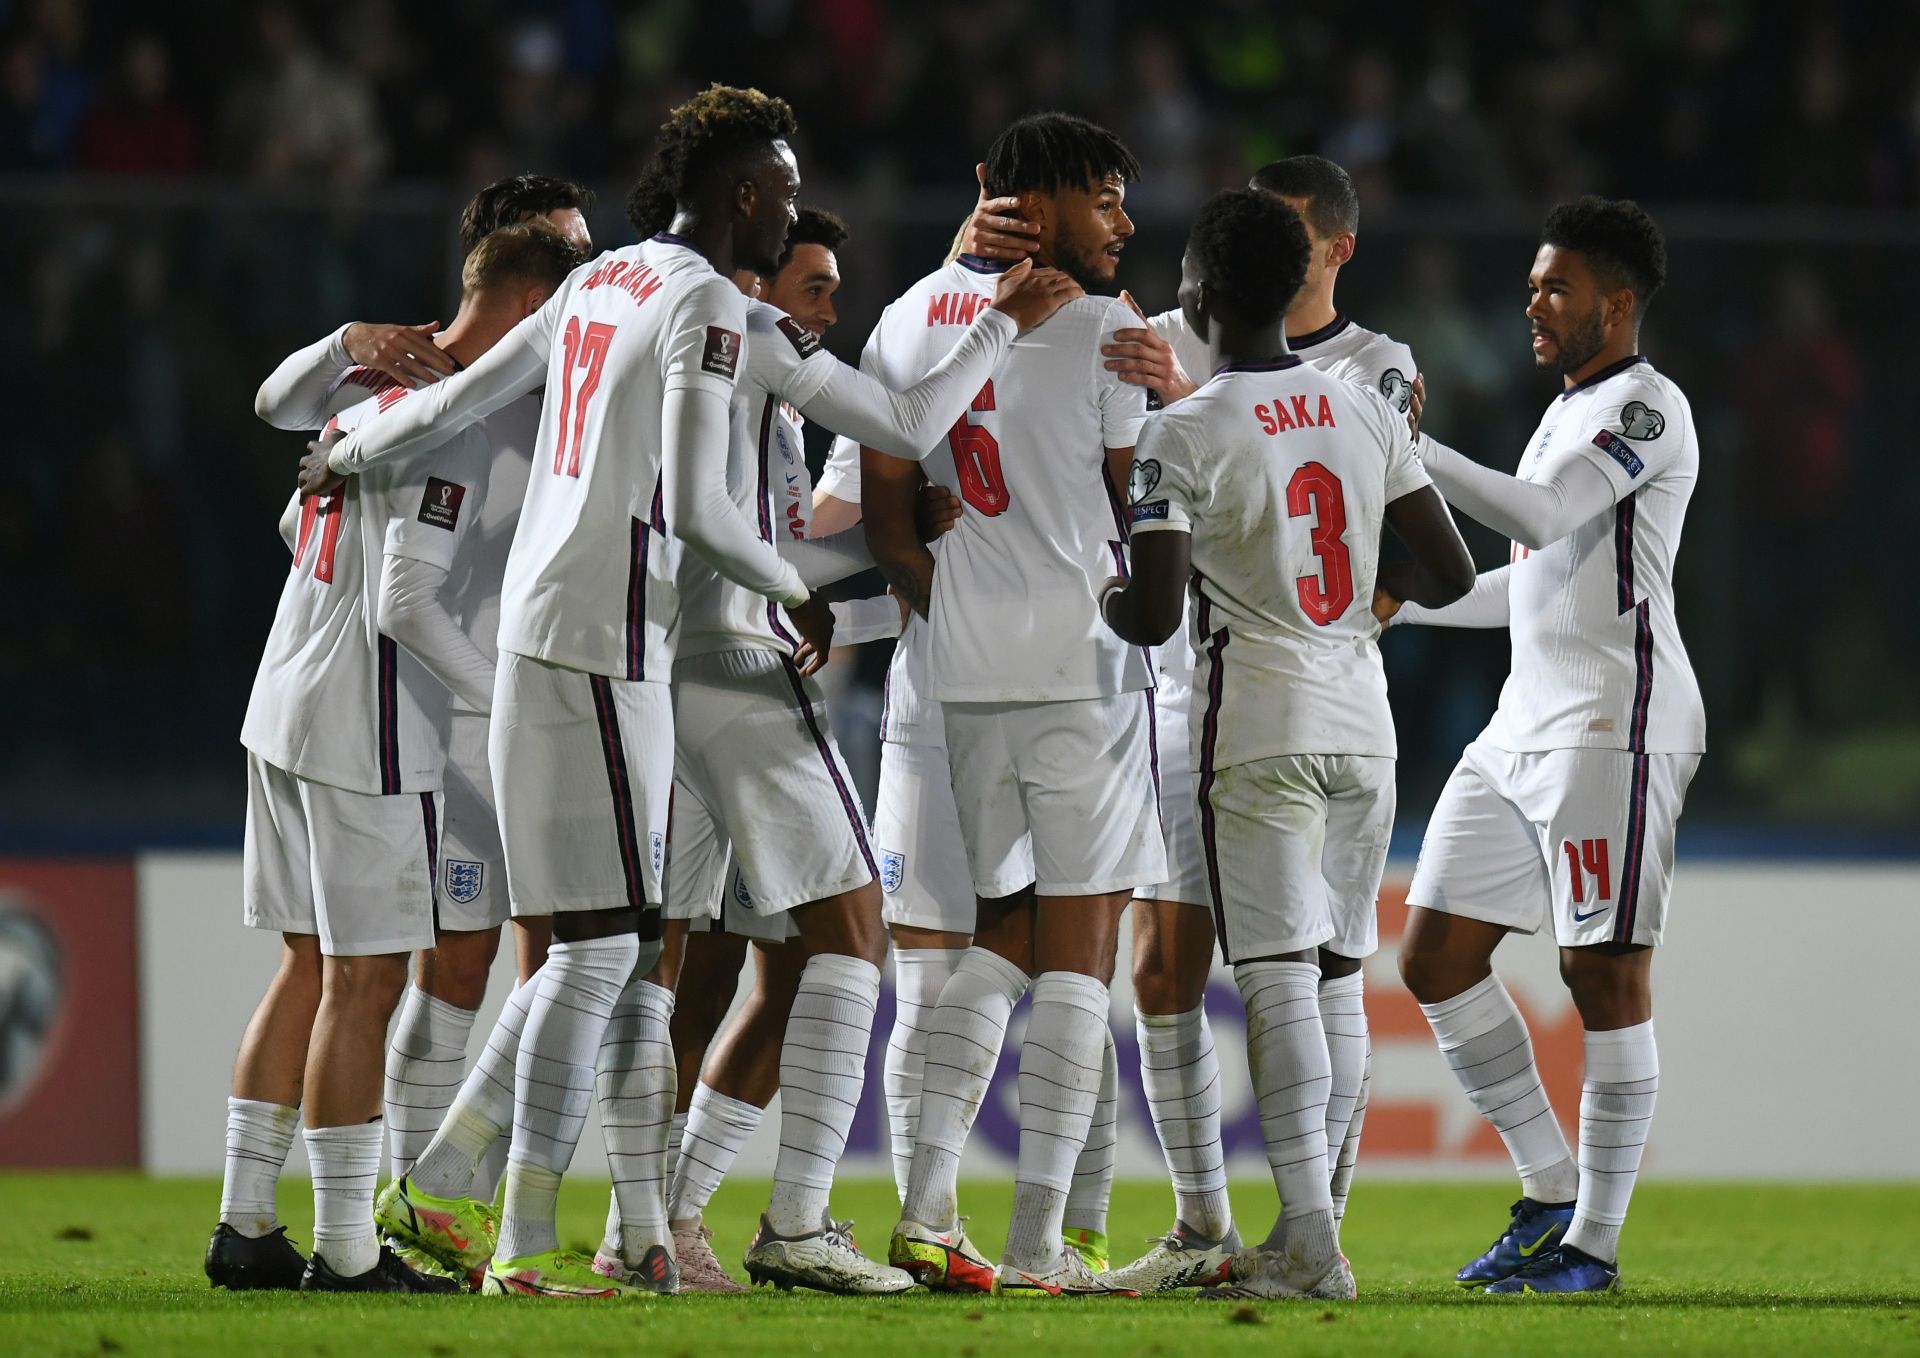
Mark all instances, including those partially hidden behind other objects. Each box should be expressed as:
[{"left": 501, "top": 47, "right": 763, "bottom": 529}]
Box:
[{"left": 1421, "top": 976, "right": 1580, "bottom": 1202}]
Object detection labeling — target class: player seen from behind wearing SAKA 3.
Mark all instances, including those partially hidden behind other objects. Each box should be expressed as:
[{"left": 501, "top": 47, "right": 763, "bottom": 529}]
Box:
[{"left": 1102, "top": 188, "right": 1473, "bottom": 1298}]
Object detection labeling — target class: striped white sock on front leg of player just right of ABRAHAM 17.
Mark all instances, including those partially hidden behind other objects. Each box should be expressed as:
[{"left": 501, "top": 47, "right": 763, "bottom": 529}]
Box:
[{"left": 766, "top": 953, "right": 879, "bottom": 1235}]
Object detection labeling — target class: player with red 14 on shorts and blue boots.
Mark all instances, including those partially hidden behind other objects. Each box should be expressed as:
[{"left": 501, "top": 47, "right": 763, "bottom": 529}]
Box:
[{"left": 1379, "top": 198, "right": 1707, "bottom": 1293}]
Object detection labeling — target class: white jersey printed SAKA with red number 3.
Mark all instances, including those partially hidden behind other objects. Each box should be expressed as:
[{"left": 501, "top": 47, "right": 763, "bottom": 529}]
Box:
[{"left": 1133, "top": 355, "right": 1432, "bottom": 768}]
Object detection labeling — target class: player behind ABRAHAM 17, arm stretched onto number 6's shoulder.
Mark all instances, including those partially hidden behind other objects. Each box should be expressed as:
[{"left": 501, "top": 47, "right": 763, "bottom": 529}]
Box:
[{"left": 583, "top": 167, "right": 1079, "bottom": 1293}]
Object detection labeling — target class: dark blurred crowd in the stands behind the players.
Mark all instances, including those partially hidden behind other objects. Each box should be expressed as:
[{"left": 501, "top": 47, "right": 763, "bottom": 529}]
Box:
[{"left": 0, "top": 0, "right": 1920, "bottom": 847}]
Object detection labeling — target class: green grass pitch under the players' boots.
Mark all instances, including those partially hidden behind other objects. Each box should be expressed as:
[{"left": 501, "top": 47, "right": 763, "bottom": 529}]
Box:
[{"left": 0, "top": 1174, "right": 1920, "bottom": 1358}]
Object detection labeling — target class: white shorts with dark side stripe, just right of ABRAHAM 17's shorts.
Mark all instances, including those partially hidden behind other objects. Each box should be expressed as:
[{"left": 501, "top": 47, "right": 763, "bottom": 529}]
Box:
[{"left": 674, "top": 651, "right": 879, "bottom": 914}]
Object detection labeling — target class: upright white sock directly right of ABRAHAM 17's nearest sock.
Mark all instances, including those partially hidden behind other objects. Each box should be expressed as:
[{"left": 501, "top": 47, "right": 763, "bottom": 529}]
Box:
[{"left": 597, "top": 976, "right": 678, "bottom": 1264}]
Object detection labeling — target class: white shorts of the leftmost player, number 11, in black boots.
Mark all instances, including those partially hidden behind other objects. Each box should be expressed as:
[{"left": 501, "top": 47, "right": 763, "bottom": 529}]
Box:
[{"left": 242, "top": 751, "right": 440, "bottom": 957}]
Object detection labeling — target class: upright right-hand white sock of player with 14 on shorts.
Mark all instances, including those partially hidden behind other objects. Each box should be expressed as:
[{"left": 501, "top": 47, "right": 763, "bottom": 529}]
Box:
[{"left": 1567, "top": 1018, "right": 1661, "bottom": 1264}]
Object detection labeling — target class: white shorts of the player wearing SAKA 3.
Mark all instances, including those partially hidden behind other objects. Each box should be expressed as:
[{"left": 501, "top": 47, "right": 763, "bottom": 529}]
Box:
[{"left": 1196, "top": 755, "right": 1394, "bottom": 964}]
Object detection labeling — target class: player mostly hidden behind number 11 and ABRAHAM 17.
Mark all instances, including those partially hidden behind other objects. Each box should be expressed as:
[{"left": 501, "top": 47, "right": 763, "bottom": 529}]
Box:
[{"left": 253, "top": 175, "right": 593, "bottom": 1221}]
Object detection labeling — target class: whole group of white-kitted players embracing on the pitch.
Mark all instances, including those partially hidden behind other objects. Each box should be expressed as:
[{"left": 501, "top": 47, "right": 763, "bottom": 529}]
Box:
[{"left": 207, "top": 85, "right": 1705, "bottom": 1298}]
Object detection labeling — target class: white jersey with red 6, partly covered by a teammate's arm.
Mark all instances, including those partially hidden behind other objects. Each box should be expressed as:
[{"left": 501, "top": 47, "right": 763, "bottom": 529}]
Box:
[{"left": 874, "top": 257, "right": 1152, "bottom": 703}]
